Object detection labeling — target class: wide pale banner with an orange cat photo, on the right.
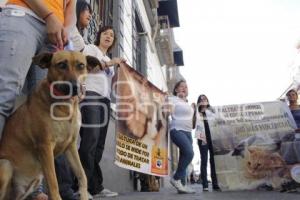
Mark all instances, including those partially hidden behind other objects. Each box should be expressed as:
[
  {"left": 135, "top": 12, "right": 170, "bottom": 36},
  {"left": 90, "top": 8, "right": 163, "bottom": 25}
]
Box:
[{"left": 207, "top": 101, "right": 300, "bottom": 190}]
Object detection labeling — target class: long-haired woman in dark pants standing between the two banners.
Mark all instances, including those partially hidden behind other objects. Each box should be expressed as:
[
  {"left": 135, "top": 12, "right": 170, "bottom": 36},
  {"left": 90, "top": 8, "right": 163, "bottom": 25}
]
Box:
[{"left": 195, "top": 94, "right": 220, "bottom": 191}]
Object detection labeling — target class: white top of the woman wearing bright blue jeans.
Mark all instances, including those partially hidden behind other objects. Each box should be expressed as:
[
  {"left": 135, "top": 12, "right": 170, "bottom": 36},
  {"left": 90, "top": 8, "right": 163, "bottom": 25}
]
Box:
[{"left": 168, "top": 96, "right": 194, "bottom": 132}]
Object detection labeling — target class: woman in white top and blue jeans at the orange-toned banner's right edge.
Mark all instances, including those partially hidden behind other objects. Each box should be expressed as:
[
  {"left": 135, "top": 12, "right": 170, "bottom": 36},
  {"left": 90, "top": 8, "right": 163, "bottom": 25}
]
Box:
[{"left": 168, "top": 80, "right": 195, "bottom": 193}]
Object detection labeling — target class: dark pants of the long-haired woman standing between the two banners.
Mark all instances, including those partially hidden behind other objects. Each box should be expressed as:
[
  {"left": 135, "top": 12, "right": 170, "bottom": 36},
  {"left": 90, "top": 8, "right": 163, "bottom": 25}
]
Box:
[{"left": 198, "top": 140, "right": 218, "bottom": 188}]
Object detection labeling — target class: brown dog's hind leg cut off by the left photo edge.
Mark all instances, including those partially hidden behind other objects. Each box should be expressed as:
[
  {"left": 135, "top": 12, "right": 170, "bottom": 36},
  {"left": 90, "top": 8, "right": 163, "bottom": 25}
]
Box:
[{"left": 0, "top": 159, "right": 13, "bottom": 200}]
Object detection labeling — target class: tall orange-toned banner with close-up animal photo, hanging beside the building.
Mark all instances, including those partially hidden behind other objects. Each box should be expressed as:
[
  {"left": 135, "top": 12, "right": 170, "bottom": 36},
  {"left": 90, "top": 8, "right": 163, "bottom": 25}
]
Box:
[{"left": 115, "top": 63, "right": 168, "bottom": 176}]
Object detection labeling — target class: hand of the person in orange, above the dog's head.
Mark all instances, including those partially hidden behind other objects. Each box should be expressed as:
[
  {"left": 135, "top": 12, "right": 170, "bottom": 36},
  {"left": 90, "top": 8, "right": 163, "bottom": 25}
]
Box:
[{"left": 45, "top": 14, "right": 68, "bottom": 50}]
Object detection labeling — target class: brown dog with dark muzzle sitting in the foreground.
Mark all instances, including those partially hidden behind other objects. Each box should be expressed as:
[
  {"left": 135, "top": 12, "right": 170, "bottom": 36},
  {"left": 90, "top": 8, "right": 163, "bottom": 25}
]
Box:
[{"left": 0, "top": 51, "right": 101, "bottom": 200}]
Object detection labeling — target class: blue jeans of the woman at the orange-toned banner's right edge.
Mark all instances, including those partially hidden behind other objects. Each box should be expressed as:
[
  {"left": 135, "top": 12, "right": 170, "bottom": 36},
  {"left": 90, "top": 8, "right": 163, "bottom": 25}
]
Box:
[{"left": 170, "top": 129, "right": 194, "bottom": 180}]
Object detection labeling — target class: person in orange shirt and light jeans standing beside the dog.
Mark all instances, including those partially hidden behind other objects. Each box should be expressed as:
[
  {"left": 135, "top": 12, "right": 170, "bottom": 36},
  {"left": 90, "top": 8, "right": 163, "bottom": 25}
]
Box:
[{"left": 0, "top": 0, "right": 76, "bottom": 139}]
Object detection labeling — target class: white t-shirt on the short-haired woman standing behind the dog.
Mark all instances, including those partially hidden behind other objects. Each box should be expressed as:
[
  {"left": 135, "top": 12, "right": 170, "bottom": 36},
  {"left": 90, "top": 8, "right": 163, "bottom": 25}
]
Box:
[{"left": 83, "top": 44, "right": 115, "bottom": 99}]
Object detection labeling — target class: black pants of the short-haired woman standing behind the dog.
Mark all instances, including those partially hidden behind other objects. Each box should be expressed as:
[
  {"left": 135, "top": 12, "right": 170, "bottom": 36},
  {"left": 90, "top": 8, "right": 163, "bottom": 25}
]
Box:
[{"left": 79, "top": 91, "right": 110, "bottom": 195}]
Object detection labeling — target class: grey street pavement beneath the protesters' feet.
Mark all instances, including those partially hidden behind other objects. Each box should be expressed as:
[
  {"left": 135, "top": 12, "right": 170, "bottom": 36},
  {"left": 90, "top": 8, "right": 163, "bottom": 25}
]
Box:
[{"left": 95, "top": 184, "right": 300, "bottom": 200}]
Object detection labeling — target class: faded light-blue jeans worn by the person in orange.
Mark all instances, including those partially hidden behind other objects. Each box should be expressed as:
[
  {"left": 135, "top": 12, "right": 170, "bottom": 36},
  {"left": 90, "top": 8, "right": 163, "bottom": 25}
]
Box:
[{"left": 0, "top": 8, "right": 47, "bottom": 138}]
